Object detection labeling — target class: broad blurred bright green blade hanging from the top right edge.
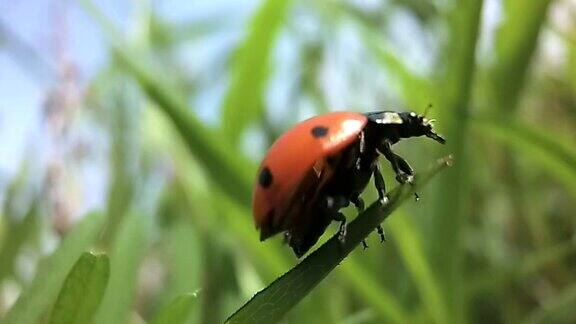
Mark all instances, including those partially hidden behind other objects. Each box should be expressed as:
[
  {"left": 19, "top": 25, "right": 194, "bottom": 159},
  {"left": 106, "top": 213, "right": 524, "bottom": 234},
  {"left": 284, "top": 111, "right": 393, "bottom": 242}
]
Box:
[{"left": 490, "top": 0, "right": 552, "bottom": 111}]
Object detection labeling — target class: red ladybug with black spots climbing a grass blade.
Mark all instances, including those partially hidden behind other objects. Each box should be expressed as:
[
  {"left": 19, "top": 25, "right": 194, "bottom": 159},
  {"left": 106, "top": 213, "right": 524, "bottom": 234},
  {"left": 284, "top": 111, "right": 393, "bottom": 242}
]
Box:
[{"left": 252, "top": 111, "right": 446, "bottom": 257}]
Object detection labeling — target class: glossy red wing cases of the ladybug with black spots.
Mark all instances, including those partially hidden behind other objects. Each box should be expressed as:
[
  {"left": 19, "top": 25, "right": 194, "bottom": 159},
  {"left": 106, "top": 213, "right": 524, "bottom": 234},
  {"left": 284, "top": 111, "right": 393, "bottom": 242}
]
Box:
[{"left": 252, "top": 112, "right": 367, "bottom": 240}]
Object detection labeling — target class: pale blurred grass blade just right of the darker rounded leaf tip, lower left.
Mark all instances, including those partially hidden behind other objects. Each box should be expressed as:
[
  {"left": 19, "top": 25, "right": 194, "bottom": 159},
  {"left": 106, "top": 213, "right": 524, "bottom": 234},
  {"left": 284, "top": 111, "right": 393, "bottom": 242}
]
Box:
[{"left": 95, "top": 211, "right": 151, "bottom": 323}]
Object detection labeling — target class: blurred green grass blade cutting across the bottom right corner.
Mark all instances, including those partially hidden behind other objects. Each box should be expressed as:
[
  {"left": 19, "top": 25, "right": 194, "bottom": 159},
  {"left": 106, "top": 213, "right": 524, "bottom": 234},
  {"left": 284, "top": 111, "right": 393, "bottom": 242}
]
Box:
[{"left": 522, "top": 284, "right": 576, "bottom": 323}]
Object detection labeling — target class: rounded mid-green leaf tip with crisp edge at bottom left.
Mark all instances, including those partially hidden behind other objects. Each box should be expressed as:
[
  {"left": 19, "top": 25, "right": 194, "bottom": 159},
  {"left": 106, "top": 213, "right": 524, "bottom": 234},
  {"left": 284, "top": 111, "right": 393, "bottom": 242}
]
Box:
[{"left": 50, "top": 252, "right": 110, "bottom": 324}]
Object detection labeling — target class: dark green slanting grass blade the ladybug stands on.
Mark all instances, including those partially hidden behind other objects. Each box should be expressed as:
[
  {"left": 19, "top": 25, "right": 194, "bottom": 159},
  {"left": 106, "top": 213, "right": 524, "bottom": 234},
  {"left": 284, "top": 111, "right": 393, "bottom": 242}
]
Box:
[{"left": 227, "top": 157, "right": 452, "bottom": 323}]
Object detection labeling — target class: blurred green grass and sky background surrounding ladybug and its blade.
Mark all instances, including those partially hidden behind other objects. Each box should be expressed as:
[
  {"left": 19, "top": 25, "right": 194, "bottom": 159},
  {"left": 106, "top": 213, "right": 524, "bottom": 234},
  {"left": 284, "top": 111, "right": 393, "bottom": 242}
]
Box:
[{"left": 0, "top": 0, "right": 576, "bottom": 324}]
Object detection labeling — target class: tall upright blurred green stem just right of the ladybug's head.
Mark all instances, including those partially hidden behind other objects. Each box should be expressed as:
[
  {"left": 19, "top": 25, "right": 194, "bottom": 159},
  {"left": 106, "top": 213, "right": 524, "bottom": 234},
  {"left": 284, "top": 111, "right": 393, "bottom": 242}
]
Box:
[{"left": 428, "top": 0, "right": 483, "bottom": 323}]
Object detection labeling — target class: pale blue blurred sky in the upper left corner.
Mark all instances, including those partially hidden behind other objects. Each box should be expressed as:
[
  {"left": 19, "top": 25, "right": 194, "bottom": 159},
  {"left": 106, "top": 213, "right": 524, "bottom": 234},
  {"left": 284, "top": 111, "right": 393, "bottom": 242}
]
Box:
[{"left": 0, "top": 0, "right": 256, "bottom": 185}]
